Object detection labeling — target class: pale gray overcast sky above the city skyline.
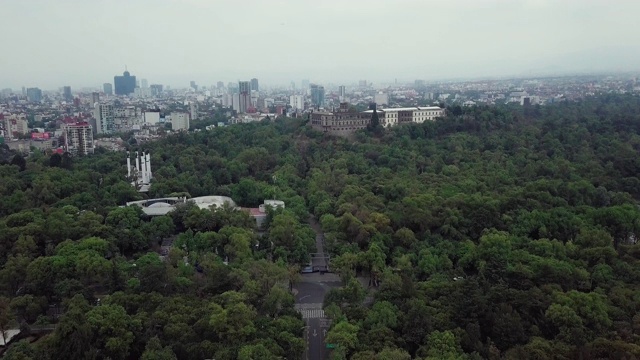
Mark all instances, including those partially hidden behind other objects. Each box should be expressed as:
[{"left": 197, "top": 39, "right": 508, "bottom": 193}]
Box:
[{"left": 0, "top": 0, "right": 640, "bottom": 89}]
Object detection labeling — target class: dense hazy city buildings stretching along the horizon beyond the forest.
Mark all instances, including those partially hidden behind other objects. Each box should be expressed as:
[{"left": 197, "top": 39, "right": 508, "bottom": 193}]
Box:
[{"left": 0, "top": 70, "right": 640, "bottom": 155}]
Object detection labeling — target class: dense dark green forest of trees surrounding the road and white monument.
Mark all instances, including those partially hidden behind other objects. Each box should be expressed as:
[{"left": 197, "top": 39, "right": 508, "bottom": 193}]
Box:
[{"left": 0, "top": 95, "right": 640, "bottom": 360}]
